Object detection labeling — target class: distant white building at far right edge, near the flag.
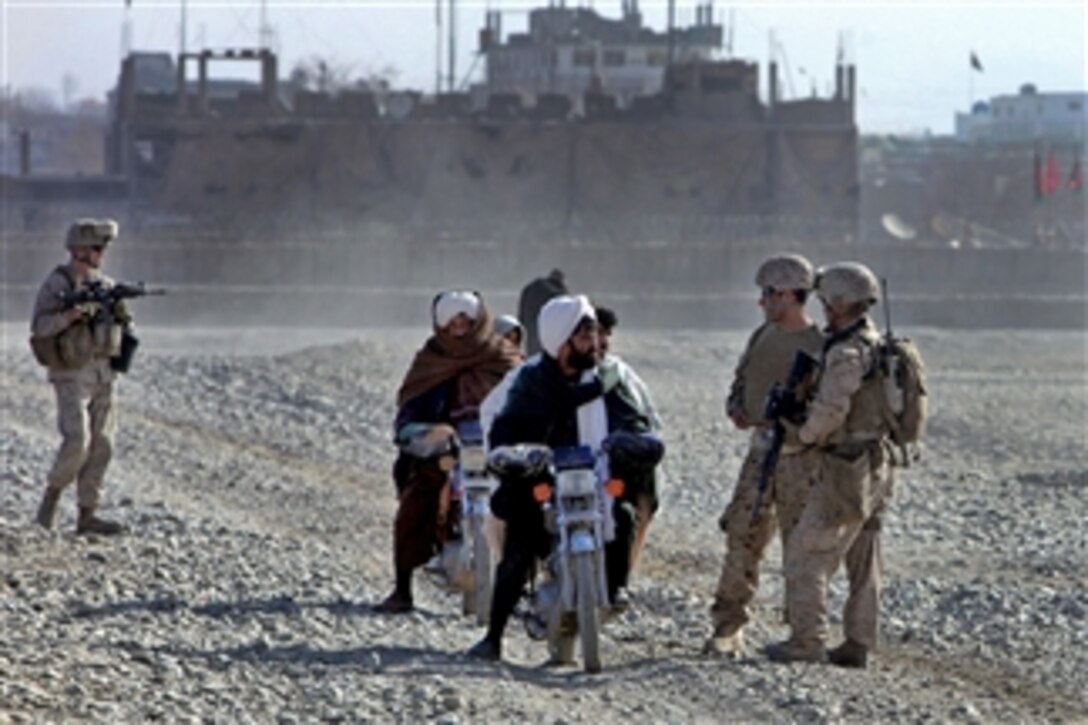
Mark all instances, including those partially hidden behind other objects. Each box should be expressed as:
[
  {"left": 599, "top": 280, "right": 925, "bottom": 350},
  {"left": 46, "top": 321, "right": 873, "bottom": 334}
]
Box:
[{"left": 955, "top": 84, "right": 1088, "bottom": 144}]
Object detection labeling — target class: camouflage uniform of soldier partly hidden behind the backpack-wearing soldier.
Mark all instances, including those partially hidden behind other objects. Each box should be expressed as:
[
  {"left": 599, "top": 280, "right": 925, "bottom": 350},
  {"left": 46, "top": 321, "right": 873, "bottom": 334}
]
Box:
[{"left": 710, "top": 323, "right": 824, "bottom": 638}]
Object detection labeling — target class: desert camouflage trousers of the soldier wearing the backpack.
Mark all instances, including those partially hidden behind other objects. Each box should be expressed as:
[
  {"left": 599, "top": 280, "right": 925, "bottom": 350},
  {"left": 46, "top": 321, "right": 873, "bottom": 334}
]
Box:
[{"left": 786, "top": 446, "right": 892, "bottom": 650}]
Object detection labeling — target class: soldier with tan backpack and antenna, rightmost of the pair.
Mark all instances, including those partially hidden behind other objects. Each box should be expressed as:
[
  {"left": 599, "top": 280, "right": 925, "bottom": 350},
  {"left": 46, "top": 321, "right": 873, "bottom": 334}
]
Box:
[{"left": 768, "top": 262, "right": 892, "bottom": 667}]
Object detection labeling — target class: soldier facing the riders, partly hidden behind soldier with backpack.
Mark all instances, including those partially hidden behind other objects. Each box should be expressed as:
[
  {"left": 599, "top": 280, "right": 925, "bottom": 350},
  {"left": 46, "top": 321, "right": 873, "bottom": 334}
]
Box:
[{"left": 704, "top": 255, "right": 824, "bottom": 658}]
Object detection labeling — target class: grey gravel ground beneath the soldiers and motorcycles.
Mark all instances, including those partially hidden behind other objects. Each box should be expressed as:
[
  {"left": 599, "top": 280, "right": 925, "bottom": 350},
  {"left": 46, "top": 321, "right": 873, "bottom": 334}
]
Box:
[{"left": 0, "top": 324, "right": 1088, "bottom": 724}]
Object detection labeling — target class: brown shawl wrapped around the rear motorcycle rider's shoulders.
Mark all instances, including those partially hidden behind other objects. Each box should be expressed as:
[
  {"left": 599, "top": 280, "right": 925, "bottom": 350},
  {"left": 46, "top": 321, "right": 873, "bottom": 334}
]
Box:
[{"left": 397, "top": 297, "right": 521, "bottom": 407}]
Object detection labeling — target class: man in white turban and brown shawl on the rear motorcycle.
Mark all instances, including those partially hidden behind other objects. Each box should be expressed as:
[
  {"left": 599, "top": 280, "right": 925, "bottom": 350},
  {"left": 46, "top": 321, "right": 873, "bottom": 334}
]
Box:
[{"left": 375, "top": 291, "right": 521, "bottom": 613}]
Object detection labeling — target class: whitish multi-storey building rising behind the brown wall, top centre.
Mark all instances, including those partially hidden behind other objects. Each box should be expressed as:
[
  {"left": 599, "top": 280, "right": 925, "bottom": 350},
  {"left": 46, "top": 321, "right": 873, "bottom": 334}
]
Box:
[{"left": 477, "top": 0, "right": 722, "bottom": 107}]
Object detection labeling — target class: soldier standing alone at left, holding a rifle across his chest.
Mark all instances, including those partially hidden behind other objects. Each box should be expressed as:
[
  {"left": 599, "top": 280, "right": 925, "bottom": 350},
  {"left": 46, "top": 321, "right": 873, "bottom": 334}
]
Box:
[{"left": 30, "top": 219, "right": 132, "bottom": 536}]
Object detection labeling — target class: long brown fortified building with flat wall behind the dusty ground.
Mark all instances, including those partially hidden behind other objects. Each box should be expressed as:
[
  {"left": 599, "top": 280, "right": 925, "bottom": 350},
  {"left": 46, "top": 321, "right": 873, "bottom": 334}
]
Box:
[{"left": 84, "top": 40, "right": 858, "bottom": 239}]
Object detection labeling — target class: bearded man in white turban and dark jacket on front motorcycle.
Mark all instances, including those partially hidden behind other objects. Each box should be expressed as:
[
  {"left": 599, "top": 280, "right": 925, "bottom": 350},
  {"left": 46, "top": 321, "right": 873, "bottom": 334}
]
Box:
[{"left": 469, "top": 296, "right": 651, "bottom": 660}]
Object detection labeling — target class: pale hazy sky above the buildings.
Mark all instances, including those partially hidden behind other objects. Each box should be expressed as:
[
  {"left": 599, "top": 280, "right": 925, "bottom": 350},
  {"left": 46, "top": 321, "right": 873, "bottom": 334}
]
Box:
[{"left": 0, "top": 0, "right": 1088, "bottom": 134}]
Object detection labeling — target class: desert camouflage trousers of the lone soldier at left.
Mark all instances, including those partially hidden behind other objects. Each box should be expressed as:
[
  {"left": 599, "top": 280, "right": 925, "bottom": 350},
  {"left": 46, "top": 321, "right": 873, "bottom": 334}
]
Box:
[{"left": 46, "top": 377, "right": 116, "bottom": 508}]
